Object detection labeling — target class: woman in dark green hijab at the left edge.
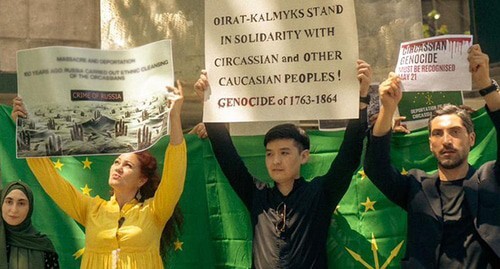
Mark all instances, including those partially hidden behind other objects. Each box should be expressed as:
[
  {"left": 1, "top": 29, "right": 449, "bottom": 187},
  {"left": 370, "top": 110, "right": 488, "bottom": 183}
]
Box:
[{"left": 0, "top": 181, "right": 59, "bottom": 269}]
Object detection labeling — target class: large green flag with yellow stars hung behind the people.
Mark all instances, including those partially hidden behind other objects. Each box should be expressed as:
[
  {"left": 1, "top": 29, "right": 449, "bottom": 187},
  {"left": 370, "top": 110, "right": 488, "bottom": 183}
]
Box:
[{"left": 0, "top": 103, "right": 496, "bottom": 268}]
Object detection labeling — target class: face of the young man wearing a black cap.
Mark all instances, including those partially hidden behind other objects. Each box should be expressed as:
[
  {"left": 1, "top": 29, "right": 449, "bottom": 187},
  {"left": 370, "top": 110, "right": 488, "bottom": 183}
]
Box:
[{"left": 266, "top": 139, "right": 309, "bottom": 184}]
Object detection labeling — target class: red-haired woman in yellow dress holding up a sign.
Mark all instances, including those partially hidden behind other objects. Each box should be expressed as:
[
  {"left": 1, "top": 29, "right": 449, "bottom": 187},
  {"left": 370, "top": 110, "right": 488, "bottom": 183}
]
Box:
[{"left": 12, "top": 82, "right": 187, "bottom": 269}]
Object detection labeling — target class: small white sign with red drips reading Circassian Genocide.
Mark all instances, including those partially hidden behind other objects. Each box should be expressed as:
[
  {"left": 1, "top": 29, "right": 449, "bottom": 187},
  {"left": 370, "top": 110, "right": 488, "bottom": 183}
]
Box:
[{"left": 396, "top": 35, "right": 472, "bottom": 91}]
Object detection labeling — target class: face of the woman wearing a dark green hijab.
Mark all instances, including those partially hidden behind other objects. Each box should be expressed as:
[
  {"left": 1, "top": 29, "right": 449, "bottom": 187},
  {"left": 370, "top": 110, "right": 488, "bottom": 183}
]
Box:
[{"left": 2, "top": 190, "right": 30, "bottom": 226}]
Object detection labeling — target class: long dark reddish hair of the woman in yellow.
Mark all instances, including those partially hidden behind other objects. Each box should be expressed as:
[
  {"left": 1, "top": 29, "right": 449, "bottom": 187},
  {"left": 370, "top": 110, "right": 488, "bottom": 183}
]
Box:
[{"left": 135, "top": 151, "right": 184, "bottom": 260}]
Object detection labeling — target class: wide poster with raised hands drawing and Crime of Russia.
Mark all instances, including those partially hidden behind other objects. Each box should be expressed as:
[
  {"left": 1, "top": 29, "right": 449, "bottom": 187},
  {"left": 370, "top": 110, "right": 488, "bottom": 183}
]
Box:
[{"left": 17, "top": 40, "right": 176, "bottom": 158}]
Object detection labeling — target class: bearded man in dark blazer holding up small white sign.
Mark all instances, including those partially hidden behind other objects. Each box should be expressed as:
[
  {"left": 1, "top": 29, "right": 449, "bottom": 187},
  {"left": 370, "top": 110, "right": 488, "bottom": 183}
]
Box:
[{"left": 364, "top": 45, "right": 500, "bottom": 269}]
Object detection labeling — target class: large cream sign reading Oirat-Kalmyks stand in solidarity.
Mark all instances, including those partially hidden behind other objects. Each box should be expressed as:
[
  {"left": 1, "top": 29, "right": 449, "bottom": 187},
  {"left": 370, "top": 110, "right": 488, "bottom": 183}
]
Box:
[{"left": 203, "top": 0, "right": 359, "bottom": 122}]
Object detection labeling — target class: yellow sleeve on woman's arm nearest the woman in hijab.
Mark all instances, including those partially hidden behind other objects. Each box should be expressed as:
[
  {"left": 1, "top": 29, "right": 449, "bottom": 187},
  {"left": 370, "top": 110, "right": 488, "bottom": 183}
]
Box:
[{"left": 27, "top": 158, "right": 92, "bottom": 226}]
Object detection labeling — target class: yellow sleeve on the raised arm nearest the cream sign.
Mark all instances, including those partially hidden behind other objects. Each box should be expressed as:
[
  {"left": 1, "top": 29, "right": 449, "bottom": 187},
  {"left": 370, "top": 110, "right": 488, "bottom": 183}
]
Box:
[{"left": 152, "top": 140, "right": 187, "bottom": 223}]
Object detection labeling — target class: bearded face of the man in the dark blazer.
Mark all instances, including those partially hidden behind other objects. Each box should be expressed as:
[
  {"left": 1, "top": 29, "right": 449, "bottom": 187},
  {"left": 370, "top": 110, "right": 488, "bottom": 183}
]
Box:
[{"left": 429, "top": 114, "right": 476, "bottom": 169}]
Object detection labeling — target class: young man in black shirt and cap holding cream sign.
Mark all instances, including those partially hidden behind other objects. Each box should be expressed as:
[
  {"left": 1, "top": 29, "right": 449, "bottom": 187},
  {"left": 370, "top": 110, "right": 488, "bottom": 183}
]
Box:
[{"left": 194, "top": 60, "right": 372, "bottom": 269}]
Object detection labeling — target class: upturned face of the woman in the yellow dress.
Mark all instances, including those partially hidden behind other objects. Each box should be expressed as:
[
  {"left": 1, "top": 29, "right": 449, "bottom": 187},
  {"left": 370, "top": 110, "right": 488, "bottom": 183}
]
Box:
[{"left": 109, "top": 153, "right": 147, "bottom": 194}]
